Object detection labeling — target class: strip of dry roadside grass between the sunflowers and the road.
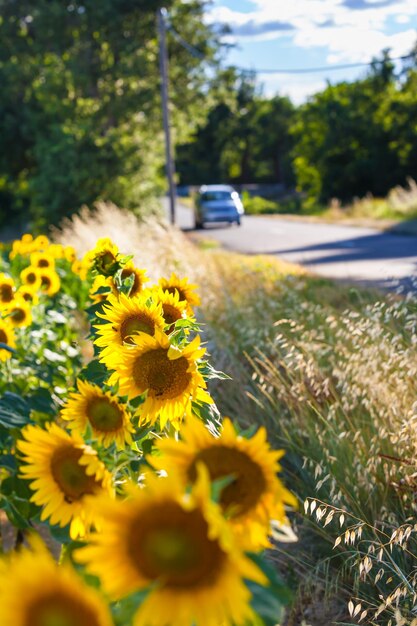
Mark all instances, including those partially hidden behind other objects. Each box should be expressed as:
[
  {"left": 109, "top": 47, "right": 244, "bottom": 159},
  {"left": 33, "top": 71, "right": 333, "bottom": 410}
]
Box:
[{"left": 52, "top": 205, "right": 417, "bottom": 626}]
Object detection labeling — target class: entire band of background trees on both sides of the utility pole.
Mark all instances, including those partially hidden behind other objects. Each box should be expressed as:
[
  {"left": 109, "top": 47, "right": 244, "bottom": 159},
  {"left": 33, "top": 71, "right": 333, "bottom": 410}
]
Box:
[{"left": 0, "top": 0, "right": 417, "bottom": 228}]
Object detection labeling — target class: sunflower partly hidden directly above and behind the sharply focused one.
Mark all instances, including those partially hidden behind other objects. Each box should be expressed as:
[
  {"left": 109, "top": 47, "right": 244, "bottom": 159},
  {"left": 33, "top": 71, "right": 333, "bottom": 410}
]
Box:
[{"left": 95, "top": 293, "right": 164, "bottom": 358}]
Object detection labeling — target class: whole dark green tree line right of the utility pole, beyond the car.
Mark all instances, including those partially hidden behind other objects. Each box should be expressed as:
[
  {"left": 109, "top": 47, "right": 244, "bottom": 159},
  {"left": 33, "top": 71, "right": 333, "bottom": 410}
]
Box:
[{"left": 177, "top": 48, "right": 417, "bottom": 204}]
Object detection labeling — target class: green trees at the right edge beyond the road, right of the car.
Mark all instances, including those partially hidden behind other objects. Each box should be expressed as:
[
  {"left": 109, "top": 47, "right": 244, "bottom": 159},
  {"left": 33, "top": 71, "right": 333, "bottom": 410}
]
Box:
[{"left": 292, "top": 52, "right": 417, "bottom": 208}]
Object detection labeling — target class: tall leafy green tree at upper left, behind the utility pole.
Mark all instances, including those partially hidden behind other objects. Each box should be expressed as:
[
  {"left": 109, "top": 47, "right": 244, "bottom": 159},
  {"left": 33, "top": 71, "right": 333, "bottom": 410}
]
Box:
[{"left": 0, "top": 0, "right": 221, "bottom": 229}]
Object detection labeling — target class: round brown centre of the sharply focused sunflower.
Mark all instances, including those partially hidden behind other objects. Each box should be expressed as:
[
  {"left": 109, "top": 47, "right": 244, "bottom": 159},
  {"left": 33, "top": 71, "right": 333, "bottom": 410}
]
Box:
[{"left": 133, "top": 348, "right": 191, "bottom": 400}]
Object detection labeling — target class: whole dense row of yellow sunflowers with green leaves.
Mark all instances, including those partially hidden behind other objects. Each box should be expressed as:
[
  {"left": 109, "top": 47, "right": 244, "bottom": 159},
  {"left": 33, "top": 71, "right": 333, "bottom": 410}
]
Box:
[{"left": 0, "top": 234, "right": 296, "bottom": 626}]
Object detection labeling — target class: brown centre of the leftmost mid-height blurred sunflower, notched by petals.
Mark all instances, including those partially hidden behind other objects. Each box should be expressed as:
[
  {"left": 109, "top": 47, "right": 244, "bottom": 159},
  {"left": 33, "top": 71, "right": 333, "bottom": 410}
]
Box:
[{"left": 51, "top": 446, "right": 100, "bottom": 503}]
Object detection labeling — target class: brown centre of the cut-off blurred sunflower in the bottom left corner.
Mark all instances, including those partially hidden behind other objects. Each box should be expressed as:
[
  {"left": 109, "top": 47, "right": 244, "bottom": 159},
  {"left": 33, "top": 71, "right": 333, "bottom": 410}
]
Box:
[{"left": 27, "top": 590, "right": 99, "bottom": 626}]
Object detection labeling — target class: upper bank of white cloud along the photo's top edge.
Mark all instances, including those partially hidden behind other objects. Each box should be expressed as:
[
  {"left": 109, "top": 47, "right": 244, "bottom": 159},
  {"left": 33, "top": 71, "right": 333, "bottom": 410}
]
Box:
[{"left": 210, "top": 0, "right": 416, "bottom": 62}]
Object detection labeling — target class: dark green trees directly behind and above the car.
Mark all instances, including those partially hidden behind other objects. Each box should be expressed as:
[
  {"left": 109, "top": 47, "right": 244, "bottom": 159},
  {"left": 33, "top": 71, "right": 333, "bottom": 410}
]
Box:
[{"left": 177, "top": 69, "right": 294, "bottom": 185}]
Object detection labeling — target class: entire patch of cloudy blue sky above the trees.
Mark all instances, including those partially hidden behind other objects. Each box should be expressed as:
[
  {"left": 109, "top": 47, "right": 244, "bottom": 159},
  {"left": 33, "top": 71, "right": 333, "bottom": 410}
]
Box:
[{"left": 207, "top": 0, "right": 417, "bottom": 104}]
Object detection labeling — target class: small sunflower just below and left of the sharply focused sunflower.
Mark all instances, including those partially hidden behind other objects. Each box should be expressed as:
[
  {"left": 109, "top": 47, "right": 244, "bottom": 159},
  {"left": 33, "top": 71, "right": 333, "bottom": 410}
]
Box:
[{"left": 61, "top": 379, "right": 133, "bottom": 449}]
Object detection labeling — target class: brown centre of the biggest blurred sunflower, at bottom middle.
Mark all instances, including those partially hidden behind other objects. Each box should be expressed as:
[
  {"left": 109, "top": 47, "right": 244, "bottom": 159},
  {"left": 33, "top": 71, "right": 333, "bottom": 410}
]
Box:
[{"left": 128, "top": 501, "right": 225, "bottom": 589}]
